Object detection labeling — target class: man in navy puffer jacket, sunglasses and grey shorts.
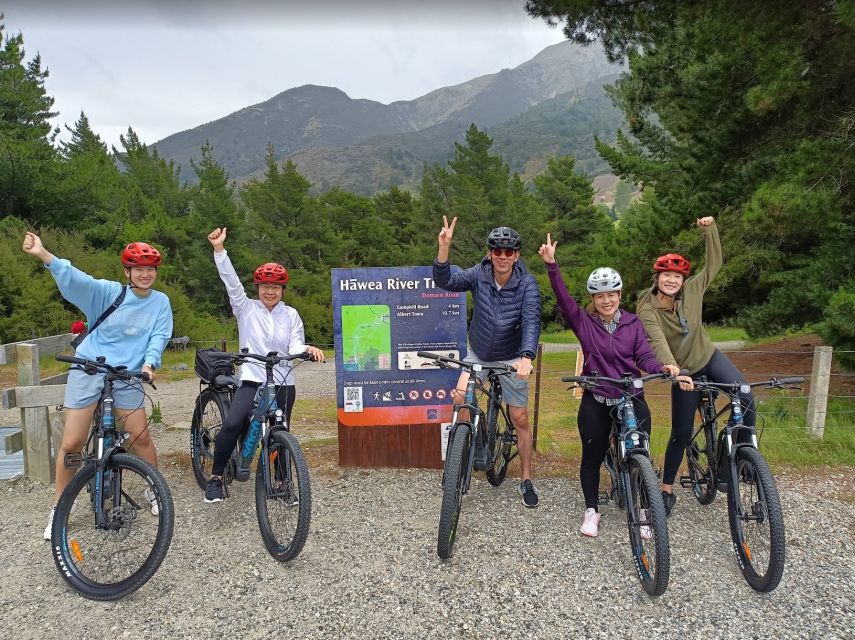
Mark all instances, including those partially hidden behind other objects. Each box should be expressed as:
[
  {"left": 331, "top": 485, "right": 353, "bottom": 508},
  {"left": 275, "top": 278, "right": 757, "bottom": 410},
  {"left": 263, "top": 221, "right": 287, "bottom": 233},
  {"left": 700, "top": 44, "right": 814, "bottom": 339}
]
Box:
[{"left": 433, "top": 216, "right": 540, "bottom": 507}]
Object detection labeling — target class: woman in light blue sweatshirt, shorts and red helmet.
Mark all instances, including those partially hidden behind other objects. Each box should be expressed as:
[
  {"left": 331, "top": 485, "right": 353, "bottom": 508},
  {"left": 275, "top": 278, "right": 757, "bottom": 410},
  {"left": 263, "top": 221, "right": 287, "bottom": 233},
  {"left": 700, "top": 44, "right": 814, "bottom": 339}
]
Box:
[{"left": 23, "top": 232, "right": 172, "bottom": 540}]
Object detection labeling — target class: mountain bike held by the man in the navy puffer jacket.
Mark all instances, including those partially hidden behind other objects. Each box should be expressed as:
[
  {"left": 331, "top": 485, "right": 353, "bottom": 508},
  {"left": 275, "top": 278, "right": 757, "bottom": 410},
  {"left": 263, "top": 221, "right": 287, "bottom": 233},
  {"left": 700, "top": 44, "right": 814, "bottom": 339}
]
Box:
[{"left": 417, "top": 351, "right": 517, "bottom": 560}]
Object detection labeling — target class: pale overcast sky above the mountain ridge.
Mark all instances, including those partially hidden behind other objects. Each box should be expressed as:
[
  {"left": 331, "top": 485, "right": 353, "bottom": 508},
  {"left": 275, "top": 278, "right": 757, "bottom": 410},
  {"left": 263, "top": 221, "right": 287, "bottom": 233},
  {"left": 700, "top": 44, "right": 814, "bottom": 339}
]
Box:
[{"left": 5, "top": 0, "right": 564, "bottom": 146}]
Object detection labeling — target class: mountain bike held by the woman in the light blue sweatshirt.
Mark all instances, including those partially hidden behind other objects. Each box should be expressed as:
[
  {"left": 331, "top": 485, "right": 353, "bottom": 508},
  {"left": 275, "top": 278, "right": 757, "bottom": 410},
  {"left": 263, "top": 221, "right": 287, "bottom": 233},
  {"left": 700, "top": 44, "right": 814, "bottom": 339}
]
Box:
[{"left": 51, "top": 355, "right": 175, "bottom": 600}]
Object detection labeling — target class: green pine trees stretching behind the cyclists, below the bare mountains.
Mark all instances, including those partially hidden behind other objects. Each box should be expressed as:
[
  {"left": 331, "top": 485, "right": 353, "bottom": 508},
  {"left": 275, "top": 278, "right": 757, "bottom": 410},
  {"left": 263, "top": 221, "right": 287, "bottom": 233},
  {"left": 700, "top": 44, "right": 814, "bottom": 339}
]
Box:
[{"left": 0, "top": 1, "right": 855, "bottom": 362}]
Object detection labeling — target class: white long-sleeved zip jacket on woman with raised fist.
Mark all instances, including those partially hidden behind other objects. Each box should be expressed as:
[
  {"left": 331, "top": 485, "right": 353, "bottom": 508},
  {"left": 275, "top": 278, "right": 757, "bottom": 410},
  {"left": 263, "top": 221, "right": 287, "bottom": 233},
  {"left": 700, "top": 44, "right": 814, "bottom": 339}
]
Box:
[{"left": 214, "top": 249, "right": 306, "bottom": 384}]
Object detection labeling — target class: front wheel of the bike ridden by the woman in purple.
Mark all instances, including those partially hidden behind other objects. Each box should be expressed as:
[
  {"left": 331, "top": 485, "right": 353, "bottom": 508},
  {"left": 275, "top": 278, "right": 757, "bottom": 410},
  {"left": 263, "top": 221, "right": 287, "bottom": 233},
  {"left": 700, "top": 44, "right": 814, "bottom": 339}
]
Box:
[{"left": 626, "top": 454, "right": 671, "bottom": 596}]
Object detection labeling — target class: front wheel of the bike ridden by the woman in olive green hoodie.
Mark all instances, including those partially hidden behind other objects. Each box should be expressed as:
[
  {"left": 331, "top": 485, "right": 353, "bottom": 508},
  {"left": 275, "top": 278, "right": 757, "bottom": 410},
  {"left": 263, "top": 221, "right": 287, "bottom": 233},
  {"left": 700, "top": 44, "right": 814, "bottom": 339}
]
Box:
[{"left": 727, "top": 447, "right": 786, "bottom": 593}]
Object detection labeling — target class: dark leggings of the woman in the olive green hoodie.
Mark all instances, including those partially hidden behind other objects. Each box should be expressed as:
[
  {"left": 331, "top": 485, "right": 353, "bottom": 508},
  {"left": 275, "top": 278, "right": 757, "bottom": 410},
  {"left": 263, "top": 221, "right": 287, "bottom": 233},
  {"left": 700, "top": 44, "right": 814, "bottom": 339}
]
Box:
[{"left": 662, "top": 349, "right": 757, "bottom": 484}]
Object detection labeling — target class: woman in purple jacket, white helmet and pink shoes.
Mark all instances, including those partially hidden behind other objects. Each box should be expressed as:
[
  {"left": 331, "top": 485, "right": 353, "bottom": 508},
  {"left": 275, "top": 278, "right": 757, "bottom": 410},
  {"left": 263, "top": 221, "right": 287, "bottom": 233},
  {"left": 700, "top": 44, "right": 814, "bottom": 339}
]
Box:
[{"left": 538, "top": 234, "right": 680, "bottom": 538}]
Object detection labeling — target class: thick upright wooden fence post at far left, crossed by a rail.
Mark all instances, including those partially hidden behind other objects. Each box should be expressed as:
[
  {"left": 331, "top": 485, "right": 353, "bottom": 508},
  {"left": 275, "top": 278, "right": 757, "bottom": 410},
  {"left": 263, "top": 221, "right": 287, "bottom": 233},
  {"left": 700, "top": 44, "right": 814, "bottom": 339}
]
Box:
[{"left": 15, "top": 343, "right": 54, "bottom": 483}]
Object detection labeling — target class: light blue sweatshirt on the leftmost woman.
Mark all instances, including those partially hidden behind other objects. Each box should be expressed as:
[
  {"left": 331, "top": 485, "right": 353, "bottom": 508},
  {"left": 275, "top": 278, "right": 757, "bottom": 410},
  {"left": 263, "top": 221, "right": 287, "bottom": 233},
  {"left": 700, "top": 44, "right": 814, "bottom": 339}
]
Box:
[{"left": 47, "top": 257, "right": 172, "bottom": 371}]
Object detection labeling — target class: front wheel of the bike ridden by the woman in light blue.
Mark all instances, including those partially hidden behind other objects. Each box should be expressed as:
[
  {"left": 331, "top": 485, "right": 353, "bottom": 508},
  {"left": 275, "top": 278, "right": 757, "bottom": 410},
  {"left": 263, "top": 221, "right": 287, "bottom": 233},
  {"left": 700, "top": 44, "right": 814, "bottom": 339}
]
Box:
[{"left": 51, "top": 453, "right": 175, "bottom": 600}]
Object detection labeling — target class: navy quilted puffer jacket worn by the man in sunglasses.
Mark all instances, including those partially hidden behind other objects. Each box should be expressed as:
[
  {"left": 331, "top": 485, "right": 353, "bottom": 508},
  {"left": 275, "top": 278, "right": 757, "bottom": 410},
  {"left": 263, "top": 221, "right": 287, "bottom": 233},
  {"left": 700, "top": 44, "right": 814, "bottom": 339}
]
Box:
[{"left": 433, "top": 256, "right": 540, "bottom": 362}]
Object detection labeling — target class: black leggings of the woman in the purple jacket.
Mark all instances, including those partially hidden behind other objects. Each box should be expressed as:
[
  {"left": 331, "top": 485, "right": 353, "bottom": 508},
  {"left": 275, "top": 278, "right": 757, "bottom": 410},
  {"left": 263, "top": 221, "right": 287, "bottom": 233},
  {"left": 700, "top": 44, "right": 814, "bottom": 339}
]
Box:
[{"left": 577, "top": 391, "right": 650, "bottom": 509}]
